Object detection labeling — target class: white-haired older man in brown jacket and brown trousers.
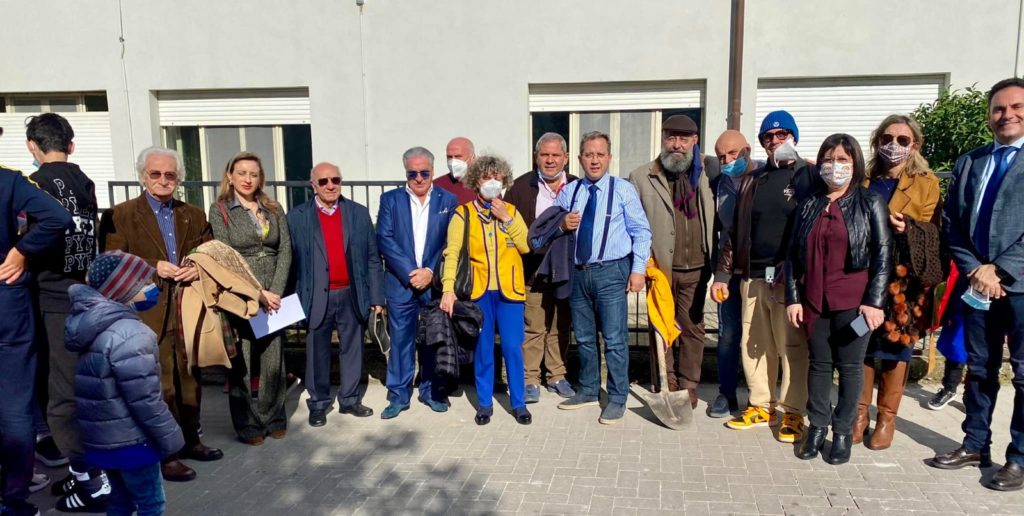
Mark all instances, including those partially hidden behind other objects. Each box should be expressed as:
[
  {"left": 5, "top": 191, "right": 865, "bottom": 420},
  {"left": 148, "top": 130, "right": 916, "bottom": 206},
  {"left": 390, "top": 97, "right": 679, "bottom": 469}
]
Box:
[{"left": 99, "top": 146, "right": 224, "bottom": 481}]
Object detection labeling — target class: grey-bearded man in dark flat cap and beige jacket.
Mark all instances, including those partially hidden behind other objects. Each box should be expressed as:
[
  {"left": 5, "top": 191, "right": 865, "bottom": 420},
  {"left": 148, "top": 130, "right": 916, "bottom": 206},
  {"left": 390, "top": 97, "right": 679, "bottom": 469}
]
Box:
[{"left": 630, "top": 115, "right": 719, "bottom": 407}]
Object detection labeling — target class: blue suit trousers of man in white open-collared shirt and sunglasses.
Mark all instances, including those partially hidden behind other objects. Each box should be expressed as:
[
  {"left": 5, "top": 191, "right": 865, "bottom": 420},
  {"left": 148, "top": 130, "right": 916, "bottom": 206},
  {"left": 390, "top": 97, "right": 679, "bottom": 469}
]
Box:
[{"left": 386, "top": 298, "right": 445, "bottom": 405}]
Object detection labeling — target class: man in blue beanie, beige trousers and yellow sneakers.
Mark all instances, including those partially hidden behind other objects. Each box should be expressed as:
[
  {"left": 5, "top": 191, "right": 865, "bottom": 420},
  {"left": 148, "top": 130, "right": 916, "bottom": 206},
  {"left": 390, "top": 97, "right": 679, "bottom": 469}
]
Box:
[{"left": 712, "top": 111, "right": 820, "bottom": 442}]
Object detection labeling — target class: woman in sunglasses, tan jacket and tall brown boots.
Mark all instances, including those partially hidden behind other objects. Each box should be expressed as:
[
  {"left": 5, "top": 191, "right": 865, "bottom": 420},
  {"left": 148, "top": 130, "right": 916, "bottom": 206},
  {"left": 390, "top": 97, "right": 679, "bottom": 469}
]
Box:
[{"left": 853, "top": 115, "right": 943, "bottom": 449}]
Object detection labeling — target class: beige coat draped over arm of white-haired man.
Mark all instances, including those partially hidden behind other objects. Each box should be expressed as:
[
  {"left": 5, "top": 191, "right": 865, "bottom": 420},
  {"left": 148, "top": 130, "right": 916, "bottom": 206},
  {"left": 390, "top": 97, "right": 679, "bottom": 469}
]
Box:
[{"left": 179, "top": 241, "right": 260, "bottom": 369}]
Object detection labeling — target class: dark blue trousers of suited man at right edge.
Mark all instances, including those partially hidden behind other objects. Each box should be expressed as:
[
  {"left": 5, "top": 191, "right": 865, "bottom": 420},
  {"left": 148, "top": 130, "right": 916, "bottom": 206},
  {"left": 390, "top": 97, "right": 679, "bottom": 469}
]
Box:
[{"left": 962, "top": 294, "right": 1024, "bottom": 466}]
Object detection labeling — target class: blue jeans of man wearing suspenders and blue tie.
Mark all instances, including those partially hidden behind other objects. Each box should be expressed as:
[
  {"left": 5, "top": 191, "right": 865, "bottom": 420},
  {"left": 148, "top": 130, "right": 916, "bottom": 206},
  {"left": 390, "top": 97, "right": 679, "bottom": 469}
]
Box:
[{"left": 569, "top": 258, "right": 630, "bottom": 404}]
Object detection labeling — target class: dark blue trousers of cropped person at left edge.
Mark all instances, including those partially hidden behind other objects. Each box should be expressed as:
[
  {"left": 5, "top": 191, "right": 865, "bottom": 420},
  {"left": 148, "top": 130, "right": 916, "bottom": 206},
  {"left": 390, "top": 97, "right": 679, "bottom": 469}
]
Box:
[{"left": 0, "top": 280, "right": 37, "bottom": 502}]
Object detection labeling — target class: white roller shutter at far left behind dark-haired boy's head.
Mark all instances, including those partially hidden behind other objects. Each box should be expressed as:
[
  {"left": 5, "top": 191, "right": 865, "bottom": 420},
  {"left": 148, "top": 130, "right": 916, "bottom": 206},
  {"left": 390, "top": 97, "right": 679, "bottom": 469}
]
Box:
[{"left": 0, "top": 112, "right": 116, "bottom": 210}]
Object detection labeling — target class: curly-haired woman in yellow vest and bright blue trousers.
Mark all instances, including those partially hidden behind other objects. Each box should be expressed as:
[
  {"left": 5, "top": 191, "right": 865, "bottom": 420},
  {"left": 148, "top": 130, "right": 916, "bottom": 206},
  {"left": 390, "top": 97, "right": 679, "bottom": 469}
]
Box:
[{"left": 440, "top": 156, "right": 532, "bottom": 425}]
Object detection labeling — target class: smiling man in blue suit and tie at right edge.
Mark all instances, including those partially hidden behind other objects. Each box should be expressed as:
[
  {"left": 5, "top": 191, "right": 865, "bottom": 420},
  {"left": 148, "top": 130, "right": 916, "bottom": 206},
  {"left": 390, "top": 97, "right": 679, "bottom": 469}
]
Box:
[{"left": 931, "top": 78, "right": 1024, "bottom": 490}]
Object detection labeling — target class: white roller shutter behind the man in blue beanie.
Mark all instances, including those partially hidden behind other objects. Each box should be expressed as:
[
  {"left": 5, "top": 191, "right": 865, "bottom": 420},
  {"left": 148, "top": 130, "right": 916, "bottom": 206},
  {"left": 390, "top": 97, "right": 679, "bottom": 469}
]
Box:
[{"left": 752, "top": 77, "right": 944, "bottom": 159}]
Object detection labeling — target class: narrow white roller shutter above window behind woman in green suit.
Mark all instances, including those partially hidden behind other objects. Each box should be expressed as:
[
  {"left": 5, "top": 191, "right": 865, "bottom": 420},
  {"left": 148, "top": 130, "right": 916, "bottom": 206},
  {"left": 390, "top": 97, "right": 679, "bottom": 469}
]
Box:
[{"left": 157, "top": 88, "right": 309, "bottom": 127}]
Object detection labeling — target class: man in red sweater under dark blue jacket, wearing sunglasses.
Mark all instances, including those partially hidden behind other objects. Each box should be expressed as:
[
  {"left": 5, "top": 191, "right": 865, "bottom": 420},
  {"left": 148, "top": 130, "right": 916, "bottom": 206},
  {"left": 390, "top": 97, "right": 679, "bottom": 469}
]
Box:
[{"left": 288, "top": 163, "right": 384, "bottom": 427}]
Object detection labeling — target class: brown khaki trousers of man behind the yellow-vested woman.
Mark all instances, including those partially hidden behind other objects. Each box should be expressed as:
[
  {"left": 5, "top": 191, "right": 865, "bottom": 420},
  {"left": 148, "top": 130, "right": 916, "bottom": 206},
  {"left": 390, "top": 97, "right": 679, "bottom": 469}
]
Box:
[{"left": 522, "top": 287, "right": 572, "bottom": 385}]
